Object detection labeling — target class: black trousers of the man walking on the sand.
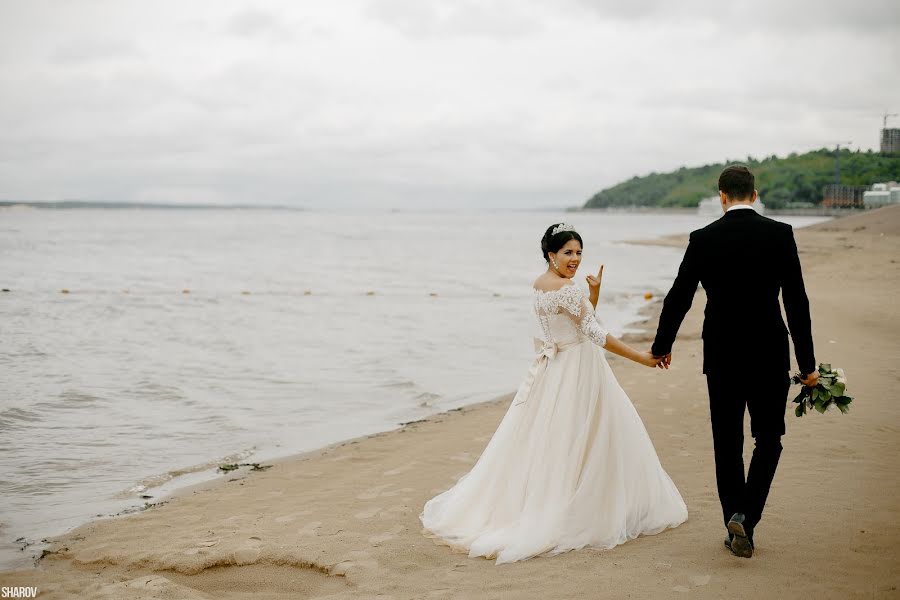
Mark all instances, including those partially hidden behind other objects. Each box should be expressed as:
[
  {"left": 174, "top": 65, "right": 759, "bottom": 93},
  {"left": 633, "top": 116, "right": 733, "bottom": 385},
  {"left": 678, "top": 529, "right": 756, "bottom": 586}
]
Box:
[{"left": 706, "top": 371, "right": 791, "bottom": 531}]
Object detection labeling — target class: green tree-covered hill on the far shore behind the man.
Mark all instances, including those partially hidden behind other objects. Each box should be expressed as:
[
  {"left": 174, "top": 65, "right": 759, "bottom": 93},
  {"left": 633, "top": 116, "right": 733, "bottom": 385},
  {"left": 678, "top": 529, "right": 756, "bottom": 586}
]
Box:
[{"left": 584, "top": 148, "right": 900, "bottom": 208}]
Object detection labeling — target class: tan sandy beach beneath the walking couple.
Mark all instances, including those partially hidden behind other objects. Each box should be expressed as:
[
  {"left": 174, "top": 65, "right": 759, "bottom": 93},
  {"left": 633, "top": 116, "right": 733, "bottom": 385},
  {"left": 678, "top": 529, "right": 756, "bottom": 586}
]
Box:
[{"left": 0, "top": 207, "right": 900, "bottom": 600}]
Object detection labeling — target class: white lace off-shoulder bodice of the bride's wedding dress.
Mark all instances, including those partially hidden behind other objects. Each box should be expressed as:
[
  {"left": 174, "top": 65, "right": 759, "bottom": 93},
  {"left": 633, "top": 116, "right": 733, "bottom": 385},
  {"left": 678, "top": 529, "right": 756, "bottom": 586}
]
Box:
[{"left": 534, "top": 284, "right": 608, "bottom": 346}]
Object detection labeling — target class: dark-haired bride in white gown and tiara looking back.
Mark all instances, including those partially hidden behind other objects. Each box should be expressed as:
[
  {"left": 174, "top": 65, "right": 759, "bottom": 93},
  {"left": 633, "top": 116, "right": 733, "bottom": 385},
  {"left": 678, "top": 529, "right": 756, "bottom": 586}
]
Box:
[{"left": 419, "top": 223, "right": 687, "bottom": 564}]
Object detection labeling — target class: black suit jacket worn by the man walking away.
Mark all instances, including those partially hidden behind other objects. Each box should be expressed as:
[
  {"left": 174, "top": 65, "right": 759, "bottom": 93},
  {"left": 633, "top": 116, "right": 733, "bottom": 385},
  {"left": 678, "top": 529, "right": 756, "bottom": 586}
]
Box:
[{"left": 652, "top": 209, "right": 816, "bottom": 376}]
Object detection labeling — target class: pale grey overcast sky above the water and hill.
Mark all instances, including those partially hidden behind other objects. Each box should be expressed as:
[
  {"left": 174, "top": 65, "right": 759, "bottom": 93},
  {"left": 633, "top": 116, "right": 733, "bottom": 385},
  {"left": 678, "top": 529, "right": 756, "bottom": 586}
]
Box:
[{"left": 0, "top": 0, "right": 900, "bottom": 209}]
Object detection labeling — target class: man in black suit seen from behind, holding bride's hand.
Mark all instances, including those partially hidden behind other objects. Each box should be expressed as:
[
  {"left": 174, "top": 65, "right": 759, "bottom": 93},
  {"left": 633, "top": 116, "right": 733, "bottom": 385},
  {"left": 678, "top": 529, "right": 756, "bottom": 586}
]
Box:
[{"left": 652, "top": 165, "right": 819, "bottom": 558}]
